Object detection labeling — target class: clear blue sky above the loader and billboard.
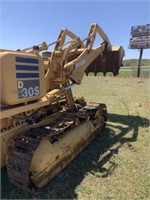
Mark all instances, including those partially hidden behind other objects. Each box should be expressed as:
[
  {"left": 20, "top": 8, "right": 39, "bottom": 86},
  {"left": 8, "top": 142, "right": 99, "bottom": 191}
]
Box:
[{"left": 0, "top": 0, "right": 150, "bottom": 59}]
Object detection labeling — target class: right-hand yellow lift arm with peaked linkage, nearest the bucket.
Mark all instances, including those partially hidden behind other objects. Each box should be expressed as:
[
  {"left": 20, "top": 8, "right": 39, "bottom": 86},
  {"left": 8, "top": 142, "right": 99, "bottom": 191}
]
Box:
[{"left": 58, "top": 24, "right": 112, "bottom": 84}]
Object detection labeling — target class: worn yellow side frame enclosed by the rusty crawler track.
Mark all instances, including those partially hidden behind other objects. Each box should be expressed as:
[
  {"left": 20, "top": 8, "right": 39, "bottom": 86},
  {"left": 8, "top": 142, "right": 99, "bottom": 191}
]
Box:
[{"left": 30, "top": 121, "right": 94, "bottom": 187}]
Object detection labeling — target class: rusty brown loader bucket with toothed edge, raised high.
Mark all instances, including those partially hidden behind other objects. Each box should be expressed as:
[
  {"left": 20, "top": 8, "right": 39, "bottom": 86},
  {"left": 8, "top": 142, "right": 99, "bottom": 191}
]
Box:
[{"left": 85, "top": 46, "right": 125, "bottom": 76}]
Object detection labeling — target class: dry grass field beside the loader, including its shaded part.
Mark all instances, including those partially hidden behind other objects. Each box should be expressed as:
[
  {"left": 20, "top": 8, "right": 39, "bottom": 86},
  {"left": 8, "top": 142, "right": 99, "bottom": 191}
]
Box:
[{"left": 2, "top": 76, "right": 150, "bottom": 200}]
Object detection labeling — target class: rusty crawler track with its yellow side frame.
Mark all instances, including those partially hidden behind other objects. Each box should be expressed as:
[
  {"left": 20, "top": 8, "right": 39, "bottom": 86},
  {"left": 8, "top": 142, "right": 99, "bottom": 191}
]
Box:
[{"left": 6, "top": 103, "right": 107, "bottom": 194}]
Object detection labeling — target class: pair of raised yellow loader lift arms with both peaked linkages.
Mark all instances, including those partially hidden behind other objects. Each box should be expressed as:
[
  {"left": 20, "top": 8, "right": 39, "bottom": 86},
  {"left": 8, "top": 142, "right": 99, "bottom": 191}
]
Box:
[{"left": 41, "top": 24, "right": 115, "bottom": 107}]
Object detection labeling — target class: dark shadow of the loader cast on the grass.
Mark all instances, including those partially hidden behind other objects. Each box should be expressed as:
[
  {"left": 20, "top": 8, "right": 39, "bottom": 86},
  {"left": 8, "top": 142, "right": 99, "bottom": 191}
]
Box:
[{"left": 1, "top": 114, "right": 149, "bottom": 199}]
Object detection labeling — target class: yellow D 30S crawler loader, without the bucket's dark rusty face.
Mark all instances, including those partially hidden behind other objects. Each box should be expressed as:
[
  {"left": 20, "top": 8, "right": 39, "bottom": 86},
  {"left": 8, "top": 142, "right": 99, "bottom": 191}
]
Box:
[{"left": 0, "top": 24, "right": 124, "bottom": 193}]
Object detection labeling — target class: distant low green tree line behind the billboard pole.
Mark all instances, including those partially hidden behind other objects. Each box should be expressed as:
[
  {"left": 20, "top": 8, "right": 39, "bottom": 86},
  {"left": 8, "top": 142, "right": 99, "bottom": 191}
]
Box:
[{"left": 123, "top": 59, "right": 150, "bottom": 67}]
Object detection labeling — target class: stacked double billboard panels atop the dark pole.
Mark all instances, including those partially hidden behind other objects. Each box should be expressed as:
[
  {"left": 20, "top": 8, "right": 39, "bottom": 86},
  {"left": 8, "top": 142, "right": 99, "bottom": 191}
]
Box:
[{"left": 129, "top": 24, "right": 150, "bottom": 49}]
